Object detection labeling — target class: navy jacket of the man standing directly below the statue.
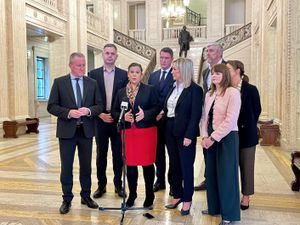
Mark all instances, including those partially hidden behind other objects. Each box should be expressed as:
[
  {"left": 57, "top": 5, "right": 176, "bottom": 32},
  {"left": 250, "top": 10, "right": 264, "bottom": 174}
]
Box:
[{"left": 148, "top": 69, "right": 174, "bottom": 107}]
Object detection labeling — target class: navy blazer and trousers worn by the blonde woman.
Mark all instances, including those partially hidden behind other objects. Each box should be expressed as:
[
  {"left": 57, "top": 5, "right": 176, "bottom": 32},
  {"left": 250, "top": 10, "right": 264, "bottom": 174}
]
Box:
[{"left": 164, "top": 82, "right": 203, "bottom": 202}]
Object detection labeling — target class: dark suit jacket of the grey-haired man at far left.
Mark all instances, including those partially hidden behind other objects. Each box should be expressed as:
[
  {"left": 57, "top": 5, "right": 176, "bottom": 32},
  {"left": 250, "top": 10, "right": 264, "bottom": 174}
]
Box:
[{"left": 47, "top": 74, "right": 103, "bottom": 138}]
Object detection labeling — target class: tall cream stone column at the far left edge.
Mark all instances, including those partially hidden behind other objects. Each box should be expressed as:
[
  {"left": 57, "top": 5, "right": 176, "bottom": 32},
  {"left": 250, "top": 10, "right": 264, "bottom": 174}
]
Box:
[{"left": 5, "top": 0, "right": 29, "bottom": 119}]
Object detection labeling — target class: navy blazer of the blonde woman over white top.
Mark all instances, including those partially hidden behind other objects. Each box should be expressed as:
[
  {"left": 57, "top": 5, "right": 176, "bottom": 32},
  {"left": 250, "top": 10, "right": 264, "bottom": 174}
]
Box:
[{"left": 164, "top": 82, "right": 203, "bottom": 139}]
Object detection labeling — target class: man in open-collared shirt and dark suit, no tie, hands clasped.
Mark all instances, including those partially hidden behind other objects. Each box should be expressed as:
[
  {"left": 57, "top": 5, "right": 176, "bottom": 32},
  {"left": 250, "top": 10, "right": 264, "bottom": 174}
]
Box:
[{"left": 89, "top": 44, "right": 128, "bottom": 198}]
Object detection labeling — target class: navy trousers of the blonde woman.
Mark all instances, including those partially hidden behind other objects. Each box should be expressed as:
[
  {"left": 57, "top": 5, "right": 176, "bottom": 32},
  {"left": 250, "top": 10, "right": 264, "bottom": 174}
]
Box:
[{"left": 165, "top": 119, "right": 196, "bottom": 202}]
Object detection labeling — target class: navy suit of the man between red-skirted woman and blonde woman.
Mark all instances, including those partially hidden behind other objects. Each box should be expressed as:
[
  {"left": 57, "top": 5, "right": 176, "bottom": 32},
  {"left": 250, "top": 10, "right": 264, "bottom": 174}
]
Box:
[{"left": 148, "top": 69, "right": 174, "bottom": 185}]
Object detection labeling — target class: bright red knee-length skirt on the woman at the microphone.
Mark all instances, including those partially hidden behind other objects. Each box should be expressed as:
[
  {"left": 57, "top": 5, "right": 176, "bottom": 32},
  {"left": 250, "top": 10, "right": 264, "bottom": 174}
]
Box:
[{"left": 123, "top": 125, "right": 157, "bottom": 166}]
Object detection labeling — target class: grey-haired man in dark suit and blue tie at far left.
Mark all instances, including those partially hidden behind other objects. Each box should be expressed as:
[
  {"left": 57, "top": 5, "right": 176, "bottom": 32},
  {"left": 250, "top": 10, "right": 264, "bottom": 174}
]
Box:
[{"left": 47, "top": 52, "right": 103, "bottom": 214}]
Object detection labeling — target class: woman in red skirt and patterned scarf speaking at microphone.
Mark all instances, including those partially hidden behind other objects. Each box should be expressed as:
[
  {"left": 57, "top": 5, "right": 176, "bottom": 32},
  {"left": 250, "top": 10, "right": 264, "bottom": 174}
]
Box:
[{"left": 112, "top": 63, "right": 161, "bottom": 207}]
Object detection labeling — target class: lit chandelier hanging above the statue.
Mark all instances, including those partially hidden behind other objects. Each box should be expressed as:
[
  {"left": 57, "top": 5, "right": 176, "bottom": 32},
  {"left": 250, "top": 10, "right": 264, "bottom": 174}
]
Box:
[{"left": 161, "top": 0, "right": 189, "bottom": 18}]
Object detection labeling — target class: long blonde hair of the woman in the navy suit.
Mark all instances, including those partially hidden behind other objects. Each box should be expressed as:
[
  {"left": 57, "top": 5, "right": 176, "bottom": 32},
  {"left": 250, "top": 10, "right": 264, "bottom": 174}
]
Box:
[{"left": 173, "top": 58, "right": 194, "bottom": 88}]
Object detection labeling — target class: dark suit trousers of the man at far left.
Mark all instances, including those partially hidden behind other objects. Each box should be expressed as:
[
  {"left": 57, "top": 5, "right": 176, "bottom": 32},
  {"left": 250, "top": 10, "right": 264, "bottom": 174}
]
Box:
[{"left": 59, "top": 127, "right": 93, "bottom": 202}]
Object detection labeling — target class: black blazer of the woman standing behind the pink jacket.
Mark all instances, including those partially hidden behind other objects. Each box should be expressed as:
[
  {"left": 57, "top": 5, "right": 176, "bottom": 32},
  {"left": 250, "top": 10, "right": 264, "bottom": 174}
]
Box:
[{"left": 238, "top": 81, "right": 261, "bottom": 148}]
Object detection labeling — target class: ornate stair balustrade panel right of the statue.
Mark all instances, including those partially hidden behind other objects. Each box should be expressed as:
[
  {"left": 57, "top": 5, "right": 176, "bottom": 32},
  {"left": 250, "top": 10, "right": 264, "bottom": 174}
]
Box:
[{"left": 216, "top": 23, "right": 252, "bottom": 50}]
